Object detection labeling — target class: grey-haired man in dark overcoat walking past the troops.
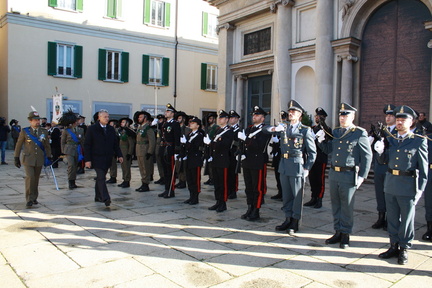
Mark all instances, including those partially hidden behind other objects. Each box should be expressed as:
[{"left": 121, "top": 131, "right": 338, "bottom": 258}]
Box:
[{"left": 84, "top": 110, "right": 123, "bottom": 206}]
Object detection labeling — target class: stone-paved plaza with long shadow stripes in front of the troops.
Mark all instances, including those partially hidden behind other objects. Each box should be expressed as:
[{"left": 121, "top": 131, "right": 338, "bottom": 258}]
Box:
[{"left": 0, "top": 150, "right": 432, "bottom": 288}]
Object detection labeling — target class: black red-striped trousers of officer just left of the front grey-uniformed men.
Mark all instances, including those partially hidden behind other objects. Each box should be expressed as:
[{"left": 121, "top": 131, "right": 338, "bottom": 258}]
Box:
[{"left": 243, "top": 165, "right": 267, "bottom": 208}]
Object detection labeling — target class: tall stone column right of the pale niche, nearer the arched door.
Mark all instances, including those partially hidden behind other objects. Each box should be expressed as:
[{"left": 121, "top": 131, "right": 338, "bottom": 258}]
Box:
[{"left": 315, "top": 0, "right": 336, "bottom": 120}]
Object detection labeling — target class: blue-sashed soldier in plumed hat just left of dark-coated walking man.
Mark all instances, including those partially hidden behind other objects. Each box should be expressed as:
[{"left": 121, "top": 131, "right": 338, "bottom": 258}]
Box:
[{"left": 59, "top": 110, "right": 84, "bottom": 189}]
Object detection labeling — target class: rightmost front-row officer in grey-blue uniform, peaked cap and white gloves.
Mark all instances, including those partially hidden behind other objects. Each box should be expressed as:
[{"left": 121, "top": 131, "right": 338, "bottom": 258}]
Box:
[{"left": 374, "top": 105, "right": 429, "bottom": 265}]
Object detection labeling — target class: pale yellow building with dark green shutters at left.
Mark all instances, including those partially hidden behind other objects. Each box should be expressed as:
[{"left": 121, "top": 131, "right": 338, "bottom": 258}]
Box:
[{"left": 0, "top": 0, "right": 218, "bottom": 125}]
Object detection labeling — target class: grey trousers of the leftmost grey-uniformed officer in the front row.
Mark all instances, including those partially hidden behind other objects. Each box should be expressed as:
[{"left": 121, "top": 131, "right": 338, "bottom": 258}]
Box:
[{"left": 280, "top": 174, "right": 304, "bottom": 219}]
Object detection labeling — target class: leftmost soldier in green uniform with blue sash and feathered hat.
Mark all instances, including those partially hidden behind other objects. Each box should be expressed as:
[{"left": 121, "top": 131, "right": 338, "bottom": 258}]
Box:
[{"left": 14, "top": 111, "right": 51, "bottom": 208}]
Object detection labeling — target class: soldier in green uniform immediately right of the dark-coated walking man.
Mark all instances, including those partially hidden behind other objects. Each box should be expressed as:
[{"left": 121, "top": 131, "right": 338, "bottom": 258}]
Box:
[{"left": 117, "top": 117, "right": 136, "bottom": 188}]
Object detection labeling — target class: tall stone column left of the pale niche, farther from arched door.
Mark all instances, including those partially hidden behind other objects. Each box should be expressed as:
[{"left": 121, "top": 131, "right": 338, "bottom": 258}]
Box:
[{"left": 270, "top": 0, "right": 294, "bottom": 119}]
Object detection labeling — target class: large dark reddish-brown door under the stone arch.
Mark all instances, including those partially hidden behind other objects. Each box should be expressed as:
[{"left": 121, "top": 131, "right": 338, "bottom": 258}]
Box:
[{"left": 360, "top": 0, "right": 432, "bottom": 128}]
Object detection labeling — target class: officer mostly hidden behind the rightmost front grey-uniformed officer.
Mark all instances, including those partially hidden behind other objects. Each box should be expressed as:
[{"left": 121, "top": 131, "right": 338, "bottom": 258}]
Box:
[{"left": 370, "top": 104, "right": 396, "bottom": 229}]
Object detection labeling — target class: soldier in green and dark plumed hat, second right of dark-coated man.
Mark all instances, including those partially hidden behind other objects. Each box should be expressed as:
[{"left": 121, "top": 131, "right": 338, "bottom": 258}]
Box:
[{"left": 135, "top": 111, "right": 156, "bottom": 192}]
